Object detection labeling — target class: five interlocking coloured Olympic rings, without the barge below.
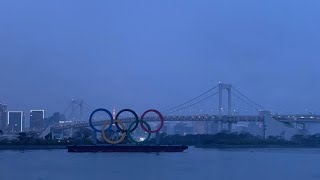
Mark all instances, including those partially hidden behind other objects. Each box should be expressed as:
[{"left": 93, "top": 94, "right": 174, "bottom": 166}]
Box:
[{"left": 89, "top": 108, "right": 164, "bottom": 144}]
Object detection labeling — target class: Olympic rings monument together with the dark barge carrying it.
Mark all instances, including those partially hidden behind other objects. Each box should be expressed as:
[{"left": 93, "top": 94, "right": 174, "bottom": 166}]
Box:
[{"left": 67, "top": 108, "right": 188, "bottom": 152}]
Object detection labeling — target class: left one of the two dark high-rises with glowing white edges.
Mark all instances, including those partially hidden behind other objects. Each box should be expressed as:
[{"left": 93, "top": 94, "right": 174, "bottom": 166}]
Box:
[{"left": 7, "top": 111, "right": 24, "bottom": 133}]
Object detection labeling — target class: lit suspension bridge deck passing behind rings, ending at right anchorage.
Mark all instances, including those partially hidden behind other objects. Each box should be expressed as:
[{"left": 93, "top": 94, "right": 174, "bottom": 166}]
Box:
[{"left": 51, "top": 115, "right": 264, "bottom": 130}]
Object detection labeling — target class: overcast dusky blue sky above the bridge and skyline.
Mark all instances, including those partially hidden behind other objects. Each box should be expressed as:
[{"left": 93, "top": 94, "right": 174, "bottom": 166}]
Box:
[{"left": 0, "top": 0, "right": 320, "bottom": 116}]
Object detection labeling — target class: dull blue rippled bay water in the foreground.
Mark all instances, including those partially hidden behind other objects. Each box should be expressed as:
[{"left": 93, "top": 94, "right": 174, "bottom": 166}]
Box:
[{"left": 0, "top": 148, "right": 320, "bottom": 180}]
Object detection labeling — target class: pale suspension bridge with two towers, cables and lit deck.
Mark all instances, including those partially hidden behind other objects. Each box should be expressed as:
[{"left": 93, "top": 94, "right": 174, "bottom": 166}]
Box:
[{"left": 47, "top": 83, "right": 320, "bottom": 138}]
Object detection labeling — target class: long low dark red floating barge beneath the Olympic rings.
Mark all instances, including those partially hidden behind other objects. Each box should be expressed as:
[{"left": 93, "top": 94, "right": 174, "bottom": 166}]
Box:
[{"left": 67, "top": 145, "right": 188, "bottom": 153}]
